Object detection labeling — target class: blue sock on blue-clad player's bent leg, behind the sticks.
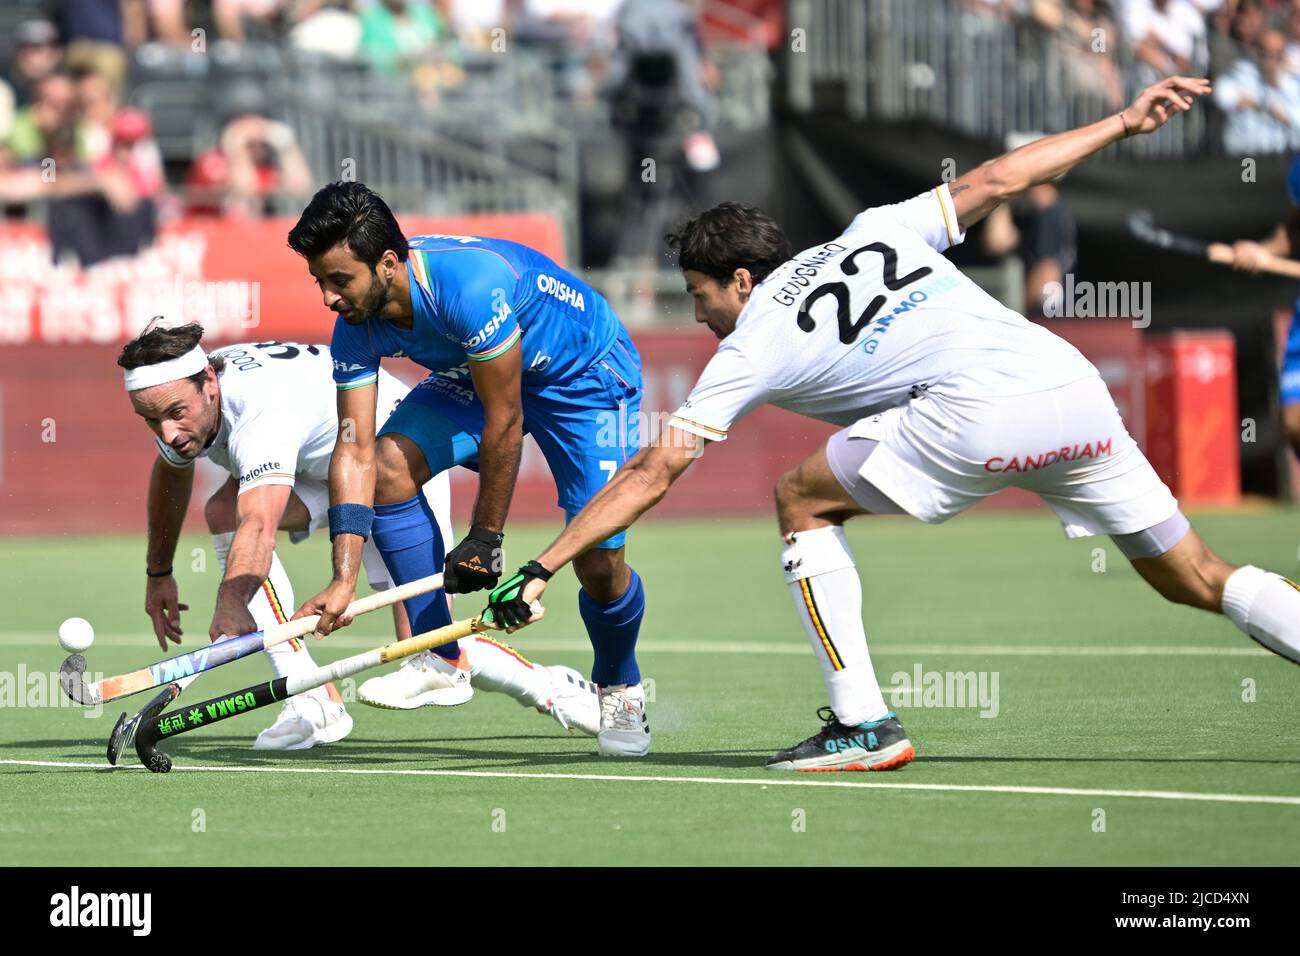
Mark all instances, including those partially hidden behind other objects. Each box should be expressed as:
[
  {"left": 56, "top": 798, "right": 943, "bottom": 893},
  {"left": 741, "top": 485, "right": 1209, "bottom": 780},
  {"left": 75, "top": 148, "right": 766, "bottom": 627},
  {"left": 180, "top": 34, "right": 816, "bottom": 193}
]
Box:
[{"left": 371, "top": 494, "right": 460, "bottom": 661}]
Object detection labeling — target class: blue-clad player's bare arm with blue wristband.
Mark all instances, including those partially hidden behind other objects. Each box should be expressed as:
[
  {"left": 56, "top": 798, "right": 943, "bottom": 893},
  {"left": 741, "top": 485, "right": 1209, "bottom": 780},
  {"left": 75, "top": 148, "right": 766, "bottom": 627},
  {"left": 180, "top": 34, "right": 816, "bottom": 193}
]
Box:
[{"left": 294, "top": 381, "right": 380, "bottom": 637}]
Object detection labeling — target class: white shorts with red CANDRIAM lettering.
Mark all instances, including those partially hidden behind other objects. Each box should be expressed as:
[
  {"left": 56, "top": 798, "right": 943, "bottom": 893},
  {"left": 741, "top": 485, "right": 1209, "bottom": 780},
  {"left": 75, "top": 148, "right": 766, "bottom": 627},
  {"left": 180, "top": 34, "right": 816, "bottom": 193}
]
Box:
[{"left": 832, "top": 376, "right": 1178, "bottom": 537}]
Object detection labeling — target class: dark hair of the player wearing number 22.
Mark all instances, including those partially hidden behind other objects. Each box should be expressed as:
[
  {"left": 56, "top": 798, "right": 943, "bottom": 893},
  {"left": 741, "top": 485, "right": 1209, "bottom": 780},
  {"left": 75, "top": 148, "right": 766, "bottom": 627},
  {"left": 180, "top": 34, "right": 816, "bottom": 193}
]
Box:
[{"left": 664, "top": 203, "right": 794, "bottom": 285}]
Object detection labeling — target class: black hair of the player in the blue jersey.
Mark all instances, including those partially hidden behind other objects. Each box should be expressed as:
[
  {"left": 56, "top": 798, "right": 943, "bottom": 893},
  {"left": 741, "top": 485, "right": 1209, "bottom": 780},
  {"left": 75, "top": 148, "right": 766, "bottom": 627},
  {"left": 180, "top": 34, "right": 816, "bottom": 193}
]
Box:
[{"left": 289, "top": 182, "right": 407, "bottom": 272}]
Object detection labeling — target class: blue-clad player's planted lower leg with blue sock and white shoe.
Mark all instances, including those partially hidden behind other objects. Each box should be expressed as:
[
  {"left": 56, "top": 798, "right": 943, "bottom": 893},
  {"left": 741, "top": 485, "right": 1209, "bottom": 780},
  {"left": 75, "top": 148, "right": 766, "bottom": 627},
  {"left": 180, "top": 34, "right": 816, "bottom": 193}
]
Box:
[{"left": 573, "top": 548, "right": 650, "bottom": 757}]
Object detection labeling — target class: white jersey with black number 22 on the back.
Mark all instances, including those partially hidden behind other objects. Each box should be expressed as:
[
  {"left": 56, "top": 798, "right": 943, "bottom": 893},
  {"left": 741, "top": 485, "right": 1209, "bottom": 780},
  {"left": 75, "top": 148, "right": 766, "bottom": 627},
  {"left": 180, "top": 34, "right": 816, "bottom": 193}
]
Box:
[{"left": 671, "top": 185, "right": 1096, "bottom": 441}]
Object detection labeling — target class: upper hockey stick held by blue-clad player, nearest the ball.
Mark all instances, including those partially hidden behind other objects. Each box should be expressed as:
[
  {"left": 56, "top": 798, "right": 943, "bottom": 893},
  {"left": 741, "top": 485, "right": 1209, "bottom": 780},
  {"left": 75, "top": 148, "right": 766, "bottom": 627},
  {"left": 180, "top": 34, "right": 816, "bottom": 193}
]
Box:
[{"left": 59, "top": 574, "right": 442, "bottom": 706}]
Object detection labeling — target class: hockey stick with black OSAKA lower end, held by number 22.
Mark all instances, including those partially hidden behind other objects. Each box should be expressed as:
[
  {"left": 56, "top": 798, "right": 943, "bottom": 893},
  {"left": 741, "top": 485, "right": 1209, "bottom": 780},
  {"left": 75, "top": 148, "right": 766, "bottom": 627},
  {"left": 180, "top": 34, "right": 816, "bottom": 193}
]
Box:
[{"left": 135, "top": 617, "right": 486, "bottom": 774}]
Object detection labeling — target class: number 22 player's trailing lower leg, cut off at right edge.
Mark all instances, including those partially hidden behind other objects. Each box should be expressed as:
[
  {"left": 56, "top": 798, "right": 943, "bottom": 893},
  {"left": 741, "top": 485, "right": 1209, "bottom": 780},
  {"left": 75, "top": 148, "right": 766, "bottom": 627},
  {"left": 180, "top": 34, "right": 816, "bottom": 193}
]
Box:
[{"left": 1117, "top": 512, "right": 1300, "bottom": 663}]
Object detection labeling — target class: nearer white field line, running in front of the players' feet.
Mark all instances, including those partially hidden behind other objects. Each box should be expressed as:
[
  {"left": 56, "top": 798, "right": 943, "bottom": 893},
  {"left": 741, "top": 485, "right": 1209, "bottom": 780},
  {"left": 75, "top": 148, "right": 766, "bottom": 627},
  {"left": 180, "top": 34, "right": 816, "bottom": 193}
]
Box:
[{"left": 0, "top": 760, "right": 1300, "bottom": 806}]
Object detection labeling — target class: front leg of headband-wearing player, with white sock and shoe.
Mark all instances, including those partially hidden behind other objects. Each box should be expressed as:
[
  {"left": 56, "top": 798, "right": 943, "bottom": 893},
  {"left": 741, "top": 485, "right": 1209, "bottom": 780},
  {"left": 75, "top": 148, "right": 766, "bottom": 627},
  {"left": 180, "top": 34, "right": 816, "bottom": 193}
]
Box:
[{"left": 203, "top": 479, "right": 352, "bottom": 750}]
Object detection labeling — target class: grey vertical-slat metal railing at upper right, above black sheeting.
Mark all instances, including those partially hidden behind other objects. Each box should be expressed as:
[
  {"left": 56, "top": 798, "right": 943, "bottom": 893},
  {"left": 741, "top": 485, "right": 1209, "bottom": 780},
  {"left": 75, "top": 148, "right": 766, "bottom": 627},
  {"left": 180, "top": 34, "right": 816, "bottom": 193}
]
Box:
[{"left": 787, "top": 0, "right": 1217, "bottom": 157}]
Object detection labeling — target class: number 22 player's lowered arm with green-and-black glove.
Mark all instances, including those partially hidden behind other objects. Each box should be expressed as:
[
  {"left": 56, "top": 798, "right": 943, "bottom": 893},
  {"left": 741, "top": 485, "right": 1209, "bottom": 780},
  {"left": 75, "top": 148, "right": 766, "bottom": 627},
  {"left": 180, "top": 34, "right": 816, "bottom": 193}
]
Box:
[{"left": 488, "top": 425, "right": 706, "bottom": 632}]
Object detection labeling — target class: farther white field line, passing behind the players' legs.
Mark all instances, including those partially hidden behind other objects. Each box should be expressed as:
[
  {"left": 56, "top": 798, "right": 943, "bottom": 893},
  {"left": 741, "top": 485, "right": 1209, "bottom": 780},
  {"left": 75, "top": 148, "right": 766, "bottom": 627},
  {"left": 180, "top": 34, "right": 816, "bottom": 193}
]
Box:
[{"left": 0, "top": 632, "right": 1273, "bottom": 662}]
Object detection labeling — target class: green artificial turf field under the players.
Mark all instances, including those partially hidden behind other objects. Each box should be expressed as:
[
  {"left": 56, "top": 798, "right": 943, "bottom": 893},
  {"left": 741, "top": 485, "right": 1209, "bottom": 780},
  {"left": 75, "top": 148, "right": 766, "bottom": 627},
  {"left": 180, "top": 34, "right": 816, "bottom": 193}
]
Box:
[{"left": 0, "top": 511, "right": 1300, "bottom": 865}]
